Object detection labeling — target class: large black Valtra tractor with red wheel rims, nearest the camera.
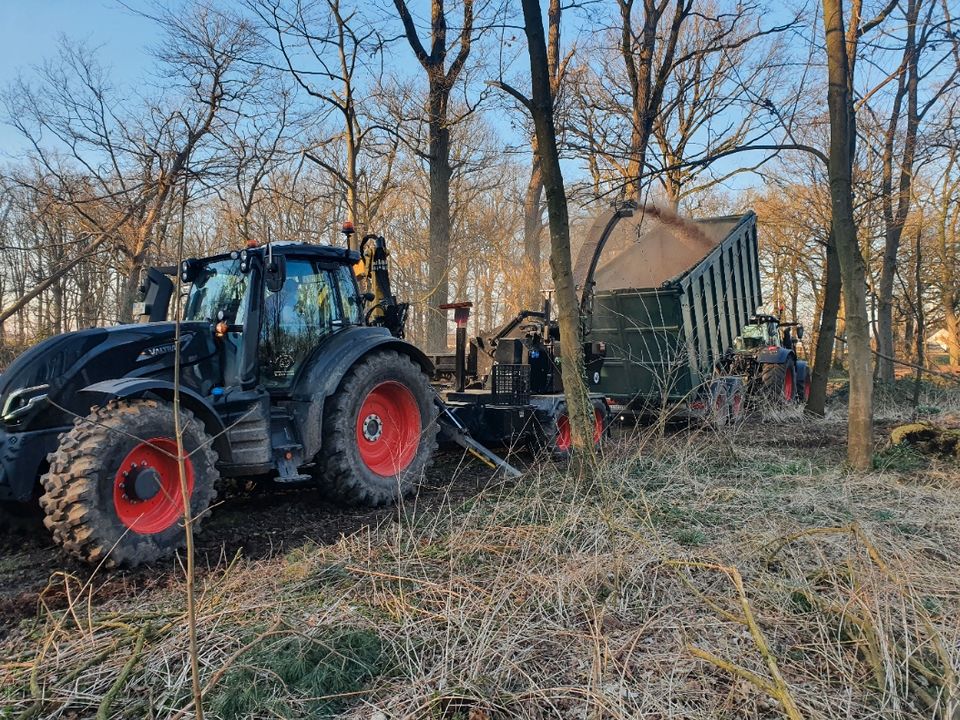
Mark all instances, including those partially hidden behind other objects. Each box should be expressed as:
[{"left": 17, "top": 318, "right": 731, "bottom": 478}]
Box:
[{"left": 0, "top": 237, "right": 437, "bottom": 565}]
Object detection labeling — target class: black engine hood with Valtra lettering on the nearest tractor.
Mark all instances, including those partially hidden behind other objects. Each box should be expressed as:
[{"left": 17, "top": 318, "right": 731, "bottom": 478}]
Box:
[{"left": 0, "top": 322, "right": 216, "bottom": 430}]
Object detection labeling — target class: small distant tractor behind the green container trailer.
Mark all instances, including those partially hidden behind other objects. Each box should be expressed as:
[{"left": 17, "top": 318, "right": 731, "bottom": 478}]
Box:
[{"left": 717, "top": 315, "right": 810, "bottom": 404}]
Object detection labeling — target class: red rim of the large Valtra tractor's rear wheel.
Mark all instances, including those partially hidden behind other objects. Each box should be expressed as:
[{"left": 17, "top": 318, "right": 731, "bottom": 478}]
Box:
[{"left": 356, "top": 380, "right": 420, "bottom": 477}]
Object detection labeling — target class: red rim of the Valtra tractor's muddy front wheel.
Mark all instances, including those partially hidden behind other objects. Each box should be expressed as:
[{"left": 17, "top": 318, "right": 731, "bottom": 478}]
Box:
[{"left": 113, "top": 437, "right": 194, "bottom": 535}]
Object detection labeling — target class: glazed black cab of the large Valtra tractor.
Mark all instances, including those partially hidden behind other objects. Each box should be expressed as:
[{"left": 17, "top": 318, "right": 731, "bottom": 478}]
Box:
[{"left": 135, "top": 243, "right": 363, "bottom": 393}]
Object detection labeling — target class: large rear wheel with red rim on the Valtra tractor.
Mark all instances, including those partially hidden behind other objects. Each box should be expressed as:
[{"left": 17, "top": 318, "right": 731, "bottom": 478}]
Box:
[{"left": 317, "top": 350, "right": 438, "bottom": 506}]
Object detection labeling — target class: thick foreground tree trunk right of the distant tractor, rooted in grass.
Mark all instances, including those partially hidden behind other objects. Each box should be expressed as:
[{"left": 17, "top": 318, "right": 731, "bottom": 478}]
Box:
[{"left": 823, "top": 0, "right": 873, "bottom": 470}]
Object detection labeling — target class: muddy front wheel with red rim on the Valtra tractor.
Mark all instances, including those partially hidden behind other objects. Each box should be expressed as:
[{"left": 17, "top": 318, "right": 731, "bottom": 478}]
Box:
[{"left": 40, "top": 400, "right": 220, "bottom": 566}]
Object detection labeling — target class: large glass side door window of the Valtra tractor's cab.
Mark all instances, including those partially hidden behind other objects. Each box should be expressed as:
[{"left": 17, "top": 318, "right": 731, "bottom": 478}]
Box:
[{"left": 259, "top": 259, "right": 342, "bottom": 388}]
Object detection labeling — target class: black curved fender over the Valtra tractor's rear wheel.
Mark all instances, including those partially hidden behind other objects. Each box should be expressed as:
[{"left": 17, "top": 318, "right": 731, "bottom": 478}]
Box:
[{"left": 291, "top": 326, "right": 433, "bottom": 458}]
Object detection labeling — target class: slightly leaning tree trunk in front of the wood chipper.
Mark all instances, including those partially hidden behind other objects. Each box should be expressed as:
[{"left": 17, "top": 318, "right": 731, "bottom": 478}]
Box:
[{"left": 522, "top": 0, "right": 593, "bottom": 457}]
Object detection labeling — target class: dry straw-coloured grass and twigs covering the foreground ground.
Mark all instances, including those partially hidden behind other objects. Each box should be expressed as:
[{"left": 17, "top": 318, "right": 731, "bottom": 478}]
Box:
[{"left": 0, "top": 408, "right": 960, "bottom": 720}]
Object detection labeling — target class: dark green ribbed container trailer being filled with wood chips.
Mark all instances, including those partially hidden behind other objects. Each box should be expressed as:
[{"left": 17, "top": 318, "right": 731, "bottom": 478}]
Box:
[{"left": 574, "top": 203, "right": 762, "bottom": 414}]
